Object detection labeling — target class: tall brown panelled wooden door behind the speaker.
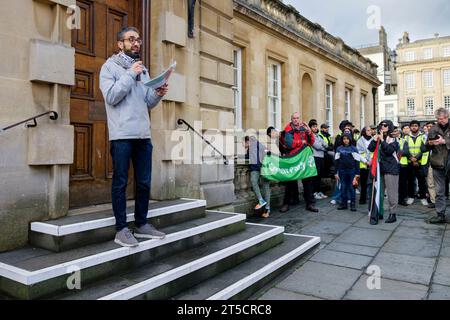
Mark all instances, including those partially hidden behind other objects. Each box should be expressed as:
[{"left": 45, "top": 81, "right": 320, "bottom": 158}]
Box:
[{"left": 70, "top": 0, "right": 142, "bottom": 208}]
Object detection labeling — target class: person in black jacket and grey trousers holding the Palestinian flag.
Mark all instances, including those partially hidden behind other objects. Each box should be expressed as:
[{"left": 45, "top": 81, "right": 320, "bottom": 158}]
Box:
[{"left": 368, "top": 120, "right": 400, "bottom": 224}]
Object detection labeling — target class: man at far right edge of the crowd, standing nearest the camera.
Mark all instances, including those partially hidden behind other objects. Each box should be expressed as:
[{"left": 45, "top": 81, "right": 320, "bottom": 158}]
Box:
[{"left": 426, "top": 108, "right": 450, "bottom": 224}]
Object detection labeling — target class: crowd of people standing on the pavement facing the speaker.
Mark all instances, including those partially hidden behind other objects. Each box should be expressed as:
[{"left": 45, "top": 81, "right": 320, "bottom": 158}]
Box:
[{"left": 245, "top": 108, "right": 450, "bottom": 224}]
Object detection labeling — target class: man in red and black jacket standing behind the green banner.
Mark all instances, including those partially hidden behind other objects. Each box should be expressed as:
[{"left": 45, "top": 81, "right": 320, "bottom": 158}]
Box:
[{"left": 281, "top": 112, "right": 319, "bottom": 212}]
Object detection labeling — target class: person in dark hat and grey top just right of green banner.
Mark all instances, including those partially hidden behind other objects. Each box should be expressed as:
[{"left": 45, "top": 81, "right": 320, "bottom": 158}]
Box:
[{"left": 308, "top": 120, "right": 328, "bottom": 200}]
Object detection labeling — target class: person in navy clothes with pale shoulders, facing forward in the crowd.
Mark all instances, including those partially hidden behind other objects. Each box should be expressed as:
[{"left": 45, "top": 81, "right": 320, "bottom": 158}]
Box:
[{"left": 335, "top": 132, "right": 360, "bottom": 211}]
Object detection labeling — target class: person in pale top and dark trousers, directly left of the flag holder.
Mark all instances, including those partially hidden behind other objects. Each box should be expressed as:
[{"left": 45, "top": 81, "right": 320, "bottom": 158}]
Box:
[{"left": 356, "top": 127, "right": 373, "bottom": 205}]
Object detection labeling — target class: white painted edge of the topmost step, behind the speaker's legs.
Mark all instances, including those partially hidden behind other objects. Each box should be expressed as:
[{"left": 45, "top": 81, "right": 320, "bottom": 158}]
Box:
[{"left": 31, "top": 200, "right": 206, "bottom": 237}]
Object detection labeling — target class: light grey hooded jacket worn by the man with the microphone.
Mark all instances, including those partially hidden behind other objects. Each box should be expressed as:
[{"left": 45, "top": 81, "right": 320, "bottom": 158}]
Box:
[{"left": 100, "top": 53, "right": 161, "bottom": 141}]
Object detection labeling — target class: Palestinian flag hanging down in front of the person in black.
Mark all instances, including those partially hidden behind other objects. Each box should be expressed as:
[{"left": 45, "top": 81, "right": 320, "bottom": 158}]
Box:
[{"left": 369, "top": 141, "right": 384, "bottom": 222}]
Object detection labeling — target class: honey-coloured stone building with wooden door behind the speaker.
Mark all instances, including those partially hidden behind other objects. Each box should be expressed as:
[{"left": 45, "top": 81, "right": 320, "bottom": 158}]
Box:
[{"left": 0, "top": 0, "right": 380, "bottom": 252}]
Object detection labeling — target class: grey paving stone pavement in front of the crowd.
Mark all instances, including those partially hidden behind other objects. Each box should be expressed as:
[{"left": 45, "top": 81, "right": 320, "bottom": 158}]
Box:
[{"left": 249, "top": 195, "right": 450, "bottom": 300}]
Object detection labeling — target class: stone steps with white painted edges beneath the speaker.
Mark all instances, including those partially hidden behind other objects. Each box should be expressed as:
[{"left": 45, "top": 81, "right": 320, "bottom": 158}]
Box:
[{"left": 0, "top": 199, "right": 320, "bottom": 300}]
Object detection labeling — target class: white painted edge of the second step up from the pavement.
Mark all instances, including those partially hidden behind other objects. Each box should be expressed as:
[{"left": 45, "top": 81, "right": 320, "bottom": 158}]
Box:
[{"left": 98, "top": 225, "right": 284, "bottom": 300}]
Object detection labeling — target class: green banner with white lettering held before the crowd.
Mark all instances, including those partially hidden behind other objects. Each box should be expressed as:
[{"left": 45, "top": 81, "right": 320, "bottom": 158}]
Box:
[{"left": 261, "top": 147, "right": 317, "bottom": 182}]
